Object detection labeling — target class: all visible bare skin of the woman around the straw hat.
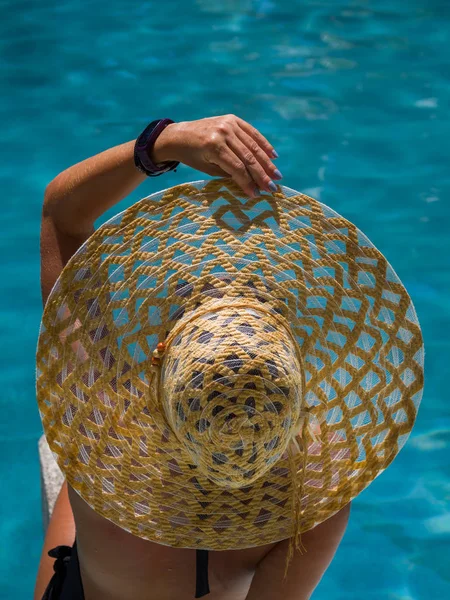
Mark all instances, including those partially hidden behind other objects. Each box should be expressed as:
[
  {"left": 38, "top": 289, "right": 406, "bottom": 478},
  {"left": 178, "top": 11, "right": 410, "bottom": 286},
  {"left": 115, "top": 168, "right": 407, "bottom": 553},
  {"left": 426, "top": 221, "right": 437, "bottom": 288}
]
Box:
[{"left": 34, "top": 115, "right": 350, "bottom": 600}]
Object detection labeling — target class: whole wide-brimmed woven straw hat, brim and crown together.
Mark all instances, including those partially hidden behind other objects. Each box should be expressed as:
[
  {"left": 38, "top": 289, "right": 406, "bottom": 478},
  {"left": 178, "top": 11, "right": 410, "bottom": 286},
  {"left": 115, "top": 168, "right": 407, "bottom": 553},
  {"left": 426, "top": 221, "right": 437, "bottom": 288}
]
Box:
[{"left": 37, "top": 179, "right": 424, "bottom": 550}]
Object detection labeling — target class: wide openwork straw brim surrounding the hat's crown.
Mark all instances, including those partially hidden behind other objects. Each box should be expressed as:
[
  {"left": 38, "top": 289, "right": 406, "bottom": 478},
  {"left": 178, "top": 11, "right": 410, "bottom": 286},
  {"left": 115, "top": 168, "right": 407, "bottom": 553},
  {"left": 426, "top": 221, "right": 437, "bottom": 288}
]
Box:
[{"left": 37, "top": 179, "right": 423, "bottom": 550}]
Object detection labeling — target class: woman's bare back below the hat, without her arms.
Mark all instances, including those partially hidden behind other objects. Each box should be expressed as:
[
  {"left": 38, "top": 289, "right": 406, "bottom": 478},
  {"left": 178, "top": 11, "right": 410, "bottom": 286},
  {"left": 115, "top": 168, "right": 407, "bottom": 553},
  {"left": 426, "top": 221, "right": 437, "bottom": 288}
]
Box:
[{"left": 69, "top": 488, "right": 276, "bottom": 600}]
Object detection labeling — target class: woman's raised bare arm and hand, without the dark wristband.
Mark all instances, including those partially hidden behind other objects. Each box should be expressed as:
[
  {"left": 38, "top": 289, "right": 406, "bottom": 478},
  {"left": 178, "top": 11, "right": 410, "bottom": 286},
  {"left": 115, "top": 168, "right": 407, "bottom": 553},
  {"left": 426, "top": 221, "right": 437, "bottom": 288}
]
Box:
[{"left": 41, "top": 115, "right": 281, "bottom": 304}]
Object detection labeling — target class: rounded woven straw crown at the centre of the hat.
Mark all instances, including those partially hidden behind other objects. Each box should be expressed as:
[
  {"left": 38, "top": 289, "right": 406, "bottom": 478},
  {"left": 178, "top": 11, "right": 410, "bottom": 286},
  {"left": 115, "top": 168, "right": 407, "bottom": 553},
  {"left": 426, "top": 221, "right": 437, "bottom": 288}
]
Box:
[{"left": 159, "top": 298, "right": 302, "bottom": 488}]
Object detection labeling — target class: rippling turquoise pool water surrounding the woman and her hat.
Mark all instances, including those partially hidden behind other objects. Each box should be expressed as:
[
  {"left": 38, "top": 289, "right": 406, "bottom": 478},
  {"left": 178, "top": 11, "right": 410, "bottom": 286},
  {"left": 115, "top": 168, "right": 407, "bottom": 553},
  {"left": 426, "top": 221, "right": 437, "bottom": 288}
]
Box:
[{"left": 0, "top": 0, "right": 450, "bottom": 600}]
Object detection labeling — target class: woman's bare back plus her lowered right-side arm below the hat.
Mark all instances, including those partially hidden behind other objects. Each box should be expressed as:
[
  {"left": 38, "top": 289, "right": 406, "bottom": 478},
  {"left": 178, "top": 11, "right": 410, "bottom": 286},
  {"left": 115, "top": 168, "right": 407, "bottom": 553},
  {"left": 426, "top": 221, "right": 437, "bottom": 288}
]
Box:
[{"left": 69, "top": 487, "right": 348, "bottom": 600}]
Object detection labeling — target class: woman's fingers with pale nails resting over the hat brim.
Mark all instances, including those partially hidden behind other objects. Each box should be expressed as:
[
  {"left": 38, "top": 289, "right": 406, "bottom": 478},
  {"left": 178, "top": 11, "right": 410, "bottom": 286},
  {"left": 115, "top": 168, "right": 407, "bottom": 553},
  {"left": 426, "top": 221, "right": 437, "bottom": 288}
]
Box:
[{"left": 227, "top": 128, "right": 281, "bottom": 192}]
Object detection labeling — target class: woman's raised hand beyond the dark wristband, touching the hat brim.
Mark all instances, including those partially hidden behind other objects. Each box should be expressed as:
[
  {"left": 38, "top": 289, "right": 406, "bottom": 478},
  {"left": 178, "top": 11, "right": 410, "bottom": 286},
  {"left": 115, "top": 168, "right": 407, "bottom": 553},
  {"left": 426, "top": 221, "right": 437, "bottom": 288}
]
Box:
[{"left": 160, "top": 115, "right": 282, "bottom": 197}]
